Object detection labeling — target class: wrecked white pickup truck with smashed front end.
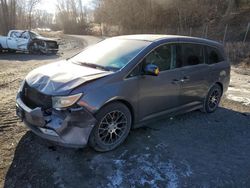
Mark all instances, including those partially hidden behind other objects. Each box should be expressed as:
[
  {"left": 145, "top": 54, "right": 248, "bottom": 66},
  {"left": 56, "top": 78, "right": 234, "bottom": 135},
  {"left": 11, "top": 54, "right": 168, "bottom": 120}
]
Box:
[{"left": 0, "top": 30, "right": 58, "bottom": 54}]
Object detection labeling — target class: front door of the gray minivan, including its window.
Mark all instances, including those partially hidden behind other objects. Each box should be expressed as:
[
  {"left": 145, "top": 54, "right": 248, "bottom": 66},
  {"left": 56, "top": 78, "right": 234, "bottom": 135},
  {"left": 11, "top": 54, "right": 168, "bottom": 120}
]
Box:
[{"left": 138, "top": 44, "right": 181, "bottom": 120}]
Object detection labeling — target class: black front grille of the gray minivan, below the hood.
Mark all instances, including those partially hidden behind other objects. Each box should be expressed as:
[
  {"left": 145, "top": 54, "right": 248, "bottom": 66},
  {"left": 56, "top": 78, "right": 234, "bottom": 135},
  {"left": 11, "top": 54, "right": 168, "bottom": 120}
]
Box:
[{"left": 21, "top": 82, "right": 52, "bottom": 110}]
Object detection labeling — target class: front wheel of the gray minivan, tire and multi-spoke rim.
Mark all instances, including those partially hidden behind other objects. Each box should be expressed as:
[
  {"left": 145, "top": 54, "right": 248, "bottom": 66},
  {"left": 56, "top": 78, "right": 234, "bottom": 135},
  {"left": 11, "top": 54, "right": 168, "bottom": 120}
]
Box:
[{"left": 89, "top": 102, "right": 132, "bottom": 152}]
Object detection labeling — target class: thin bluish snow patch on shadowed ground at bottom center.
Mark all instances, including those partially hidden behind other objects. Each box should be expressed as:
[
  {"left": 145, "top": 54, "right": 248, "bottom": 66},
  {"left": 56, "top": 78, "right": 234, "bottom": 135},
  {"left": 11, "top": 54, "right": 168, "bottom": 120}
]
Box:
[{"left": 91, "top": 152, "right": 192, "bottom": 188}]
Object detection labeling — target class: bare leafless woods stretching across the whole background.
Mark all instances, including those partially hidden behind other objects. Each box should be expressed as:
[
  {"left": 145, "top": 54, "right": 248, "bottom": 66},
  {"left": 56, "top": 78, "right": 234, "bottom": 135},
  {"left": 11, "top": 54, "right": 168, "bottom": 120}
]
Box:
[{"left": 0, "top": 0, "right": 250, "bottom": 64}]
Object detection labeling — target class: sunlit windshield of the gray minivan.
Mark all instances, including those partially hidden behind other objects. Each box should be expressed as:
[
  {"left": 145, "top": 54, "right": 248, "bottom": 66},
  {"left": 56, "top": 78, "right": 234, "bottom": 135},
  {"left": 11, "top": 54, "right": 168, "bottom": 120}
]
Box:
[{"left": 70, "top": 38, "right": 150, "bottom": 71}]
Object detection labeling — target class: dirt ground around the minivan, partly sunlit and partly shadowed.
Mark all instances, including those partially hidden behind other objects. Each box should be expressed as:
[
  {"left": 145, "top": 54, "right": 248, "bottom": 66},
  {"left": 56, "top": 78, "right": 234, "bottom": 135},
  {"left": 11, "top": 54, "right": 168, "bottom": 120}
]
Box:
[{"left": 0, "top": 36, "right": 250, "bottom": 188}]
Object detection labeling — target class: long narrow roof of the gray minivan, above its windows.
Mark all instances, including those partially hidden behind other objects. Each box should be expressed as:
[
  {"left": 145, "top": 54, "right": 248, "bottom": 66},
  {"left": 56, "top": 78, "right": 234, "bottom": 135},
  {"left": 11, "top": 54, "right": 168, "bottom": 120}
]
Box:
[{"left": 114, "top": 34, "right": 222, "bottom": 46}]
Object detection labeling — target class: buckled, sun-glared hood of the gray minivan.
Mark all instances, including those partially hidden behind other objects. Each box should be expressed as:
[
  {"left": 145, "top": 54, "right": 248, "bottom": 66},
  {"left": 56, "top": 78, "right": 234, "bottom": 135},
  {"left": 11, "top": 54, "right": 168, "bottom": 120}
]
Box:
[{"left": 25, "top": 61, "right": 112, "bottom": 96}]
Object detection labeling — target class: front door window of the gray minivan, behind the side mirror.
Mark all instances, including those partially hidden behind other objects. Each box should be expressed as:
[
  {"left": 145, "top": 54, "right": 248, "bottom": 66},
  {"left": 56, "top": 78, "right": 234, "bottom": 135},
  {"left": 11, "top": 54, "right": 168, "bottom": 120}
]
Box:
[{"left": 143, "top": 45, "right": 172, "bottom": 71}]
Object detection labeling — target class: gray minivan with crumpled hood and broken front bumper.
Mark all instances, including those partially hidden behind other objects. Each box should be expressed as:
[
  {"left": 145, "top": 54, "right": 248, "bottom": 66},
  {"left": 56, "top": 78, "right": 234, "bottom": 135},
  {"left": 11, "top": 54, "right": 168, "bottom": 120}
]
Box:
[{"left": 16, "top": 35, "right": 230, "bottom": 151}]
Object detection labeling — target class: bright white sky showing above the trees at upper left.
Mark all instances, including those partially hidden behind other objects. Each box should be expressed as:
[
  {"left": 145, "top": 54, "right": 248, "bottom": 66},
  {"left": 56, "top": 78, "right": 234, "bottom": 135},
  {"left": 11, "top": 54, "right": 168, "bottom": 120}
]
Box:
[{"left": 36, "top": 0, "right": 92, "bottom": 13}]
